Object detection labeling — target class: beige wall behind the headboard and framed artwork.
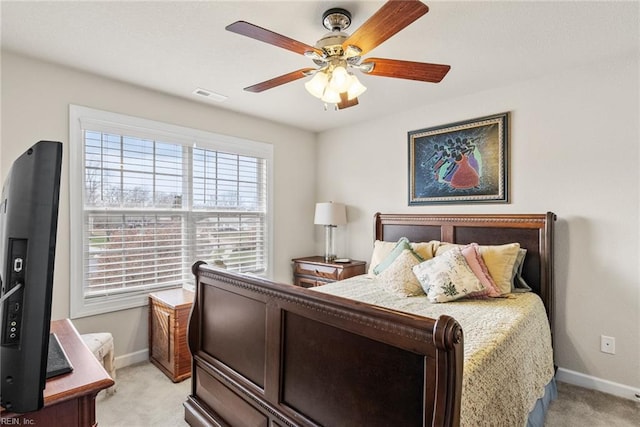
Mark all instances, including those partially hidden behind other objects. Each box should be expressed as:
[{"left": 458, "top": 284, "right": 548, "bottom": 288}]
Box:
[{"left": 317, "top": 58, "right": 640, "bottom": 389}]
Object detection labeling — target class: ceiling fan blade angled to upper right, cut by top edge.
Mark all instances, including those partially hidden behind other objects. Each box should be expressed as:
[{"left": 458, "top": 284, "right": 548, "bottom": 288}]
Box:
[{"left": 342, "top": 0, "right": 429, "bottom": 55}]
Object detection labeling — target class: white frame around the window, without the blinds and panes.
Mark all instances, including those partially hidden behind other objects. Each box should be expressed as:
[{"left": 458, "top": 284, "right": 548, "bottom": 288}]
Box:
[{"left": 69, "top": 104, "right": 273, "bottom": 319}]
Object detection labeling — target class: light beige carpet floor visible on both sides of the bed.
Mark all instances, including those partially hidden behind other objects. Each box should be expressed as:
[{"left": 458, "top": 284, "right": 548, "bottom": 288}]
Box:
[{"left": 96, "top": 363, "right": 640, "bottom": 427}]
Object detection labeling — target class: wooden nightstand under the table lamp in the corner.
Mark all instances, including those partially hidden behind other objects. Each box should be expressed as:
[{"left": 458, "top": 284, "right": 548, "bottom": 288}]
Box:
[{"left": 293, "top": 256, "right": 367, "bottom": 288}]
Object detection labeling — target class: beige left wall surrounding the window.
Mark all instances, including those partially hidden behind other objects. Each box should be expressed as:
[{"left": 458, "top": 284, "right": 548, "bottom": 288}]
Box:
[{"left": 0, "top": 51, "right": 316, "bottom": 362}]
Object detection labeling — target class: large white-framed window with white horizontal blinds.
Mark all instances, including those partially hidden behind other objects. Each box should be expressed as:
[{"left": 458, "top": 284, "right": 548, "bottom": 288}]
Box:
[{"left": 70, "top": 106, "right": 273, "bottom": 317}]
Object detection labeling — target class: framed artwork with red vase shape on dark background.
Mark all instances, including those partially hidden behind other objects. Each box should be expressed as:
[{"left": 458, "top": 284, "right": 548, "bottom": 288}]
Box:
[{"left": 408, "top": 113, "right": 509, "bottom": 205}]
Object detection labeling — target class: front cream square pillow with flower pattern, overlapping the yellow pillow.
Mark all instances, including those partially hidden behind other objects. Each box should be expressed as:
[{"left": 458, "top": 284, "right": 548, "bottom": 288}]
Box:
[{"left": 413, "top": 247, "right": 488, "bottom": 302}]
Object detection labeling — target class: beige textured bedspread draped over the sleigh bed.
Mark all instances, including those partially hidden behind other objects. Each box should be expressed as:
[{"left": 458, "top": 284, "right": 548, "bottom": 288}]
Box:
[{"left": 313, "top": 275, "right": 554, "bottom": 427}]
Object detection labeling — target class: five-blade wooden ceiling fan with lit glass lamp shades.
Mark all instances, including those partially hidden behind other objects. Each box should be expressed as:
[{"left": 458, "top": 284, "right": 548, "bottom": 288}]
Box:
[{"left": 226, "top": 0, "right": 451, "bottom": 109}]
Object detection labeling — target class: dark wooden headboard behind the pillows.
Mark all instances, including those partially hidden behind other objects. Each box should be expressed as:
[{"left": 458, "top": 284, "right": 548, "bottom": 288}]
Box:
[{"left": 374, "top": 212, "right": 556, "bottom": 327}]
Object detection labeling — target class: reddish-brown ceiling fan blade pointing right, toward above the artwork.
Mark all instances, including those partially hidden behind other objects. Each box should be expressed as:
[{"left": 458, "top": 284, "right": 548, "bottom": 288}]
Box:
[{"left": 361, "top": 58, "right": 451, "bottom": 83}]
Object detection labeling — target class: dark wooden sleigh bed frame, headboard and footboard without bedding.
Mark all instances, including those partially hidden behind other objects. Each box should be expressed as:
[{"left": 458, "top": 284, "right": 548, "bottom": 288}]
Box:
[{"left": 184, "top": 213, "right": 555, "bottom": 427}]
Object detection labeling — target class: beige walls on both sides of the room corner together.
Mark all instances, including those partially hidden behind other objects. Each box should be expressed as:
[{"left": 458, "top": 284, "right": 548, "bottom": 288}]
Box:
[{"left": 0, "top": 52, "right": 640, "bottom": 398}]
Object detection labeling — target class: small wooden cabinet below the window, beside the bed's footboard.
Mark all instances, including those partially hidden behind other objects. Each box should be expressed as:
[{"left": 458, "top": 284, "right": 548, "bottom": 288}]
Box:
[{"left": 149, "top": 289, "right": 194, "bottom": 382}]
